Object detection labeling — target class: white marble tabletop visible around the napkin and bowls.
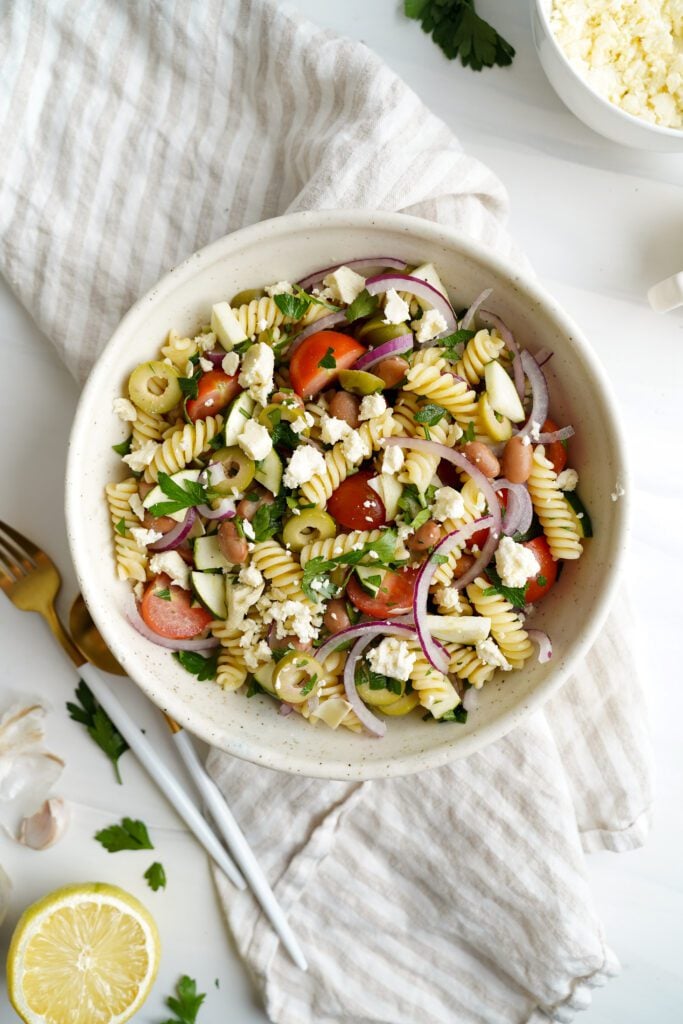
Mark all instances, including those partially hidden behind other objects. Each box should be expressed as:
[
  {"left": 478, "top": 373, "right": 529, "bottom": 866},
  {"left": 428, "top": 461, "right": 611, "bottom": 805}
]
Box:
[{"left": 0, "top": 0, "right": 683, "bottom": 1024}]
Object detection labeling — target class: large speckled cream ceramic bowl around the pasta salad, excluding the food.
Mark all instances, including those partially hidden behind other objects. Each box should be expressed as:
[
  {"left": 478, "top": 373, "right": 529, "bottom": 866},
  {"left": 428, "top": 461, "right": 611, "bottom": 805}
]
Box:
[{"left": 67, "top": 211, "right": 629, "bottom": 778}]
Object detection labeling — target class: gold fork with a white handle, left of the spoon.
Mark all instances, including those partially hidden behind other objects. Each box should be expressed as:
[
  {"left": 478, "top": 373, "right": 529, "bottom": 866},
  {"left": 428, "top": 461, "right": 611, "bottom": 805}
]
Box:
[{"left": 0, "top": 521, "right": 245, "bottom": 889}]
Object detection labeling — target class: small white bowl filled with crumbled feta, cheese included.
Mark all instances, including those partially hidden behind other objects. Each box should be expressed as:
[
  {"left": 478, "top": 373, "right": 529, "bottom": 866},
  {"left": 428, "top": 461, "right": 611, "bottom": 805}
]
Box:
[{"left": 531, "top": 0, "right": 683, "bottom": 153}]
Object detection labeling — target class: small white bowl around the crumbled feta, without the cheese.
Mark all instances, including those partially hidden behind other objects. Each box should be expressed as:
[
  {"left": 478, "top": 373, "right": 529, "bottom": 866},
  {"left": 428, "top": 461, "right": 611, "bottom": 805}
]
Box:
[{"left": 531, "top": 0, "right": 683, "bottom": 153}]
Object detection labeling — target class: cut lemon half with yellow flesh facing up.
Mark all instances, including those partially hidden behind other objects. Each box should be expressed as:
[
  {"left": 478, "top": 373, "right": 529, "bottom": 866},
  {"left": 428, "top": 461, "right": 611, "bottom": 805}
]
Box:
[{"left": 7, "top": 882, "right": 161, "bottom": 1024}]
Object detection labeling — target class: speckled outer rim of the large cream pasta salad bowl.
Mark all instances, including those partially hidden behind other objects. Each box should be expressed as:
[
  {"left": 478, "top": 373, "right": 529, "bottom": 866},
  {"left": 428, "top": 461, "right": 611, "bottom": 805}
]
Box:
[{"left": 66, "top": 210, "right": 631, "bottom": 780}]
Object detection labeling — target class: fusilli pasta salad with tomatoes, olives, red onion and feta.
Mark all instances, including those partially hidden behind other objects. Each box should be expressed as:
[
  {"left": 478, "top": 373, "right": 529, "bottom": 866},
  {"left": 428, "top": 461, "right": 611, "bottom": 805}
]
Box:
[{"left": 106, "top": 257, "right": 592, "bottom": 736}]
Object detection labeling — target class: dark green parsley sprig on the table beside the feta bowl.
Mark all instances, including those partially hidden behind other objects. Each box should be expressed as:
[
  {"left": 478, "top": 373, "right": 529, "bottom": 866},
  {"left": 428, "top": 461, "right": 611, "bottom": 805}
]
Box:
[{"left": 403, "top": 0, "right": 515, "bottom": 71}]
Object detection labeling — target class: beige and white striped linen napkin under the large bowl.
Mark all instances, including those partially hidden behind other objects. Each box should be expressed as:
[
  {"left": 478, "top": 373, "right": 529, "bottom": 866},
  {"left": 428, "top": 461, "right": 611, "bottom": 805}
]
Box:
[{"left": 0, "top": 0, "right": 651, "bottom": 1024}]
